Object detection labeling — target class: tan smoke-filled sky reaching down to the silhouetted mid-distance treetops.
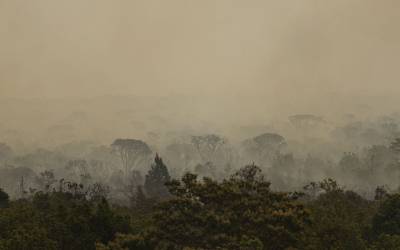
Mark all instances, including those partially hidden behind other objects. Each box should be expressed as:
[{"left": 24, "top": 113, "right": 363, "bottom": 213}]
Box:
[{"left": 0, "top": 0, "right": 400, "bottom": 153}]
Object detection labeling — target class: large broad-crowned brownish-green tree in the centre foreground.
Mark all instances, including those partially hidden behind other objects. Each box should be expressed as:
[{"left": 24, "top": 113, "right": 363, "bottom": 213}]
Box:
[{"left": 150, "top": 165, "right": 309, "bottom": 249}]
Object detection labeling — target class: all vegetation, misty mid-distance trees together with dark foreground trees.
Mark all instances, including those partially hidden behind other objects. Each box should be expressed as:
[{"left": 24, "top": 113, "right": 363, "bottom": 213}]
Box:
[{"left": 0, "top": 122, "right": 400, "bottom": 250}]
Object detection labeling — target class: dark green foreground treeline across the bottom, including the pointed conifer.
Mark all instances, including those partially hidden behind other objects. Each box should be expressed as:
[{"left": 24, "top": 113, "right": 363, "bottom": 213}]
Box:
[{"left": 0, "top": 156, "right": 400, "bottom": 250}]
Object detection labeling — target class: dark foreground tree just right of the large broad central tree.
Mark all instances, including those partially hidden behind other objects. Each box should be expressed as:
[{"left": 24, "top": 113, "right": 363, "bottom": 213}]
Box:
[{"left": 308, "top": 182, "right": 374, "bottom": 249}]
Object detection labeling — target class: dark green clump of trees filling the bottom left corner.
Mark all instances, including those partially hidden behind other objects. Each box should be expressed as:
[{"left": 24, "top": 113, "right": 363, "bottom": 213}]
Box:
[{"left": 0, "top": 184, "right": 130, "bottom": 250}]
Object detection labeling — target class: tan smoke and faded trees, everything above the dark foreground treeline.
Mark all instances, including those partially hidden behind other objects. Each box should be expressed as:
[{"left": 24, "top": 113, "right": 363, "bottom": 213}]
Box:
[{"left": 0, "top": 0, "right": 400, "bottom": 203}]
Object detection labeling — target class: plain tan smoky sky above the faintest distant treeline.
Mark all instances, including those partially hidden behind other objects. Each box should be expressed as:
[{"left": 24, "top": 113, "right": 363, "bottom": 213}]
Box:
[{"left": 0, "top": 0, "right": 400, "bottom": 112}]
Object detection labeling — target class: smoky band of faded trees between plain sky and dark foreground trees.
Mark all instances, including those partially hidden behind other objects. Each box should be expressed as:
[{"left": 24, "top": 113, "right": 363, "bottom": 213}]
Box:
[{"left": 0, "top": 96, "right": 400, "bottom": 200}]
